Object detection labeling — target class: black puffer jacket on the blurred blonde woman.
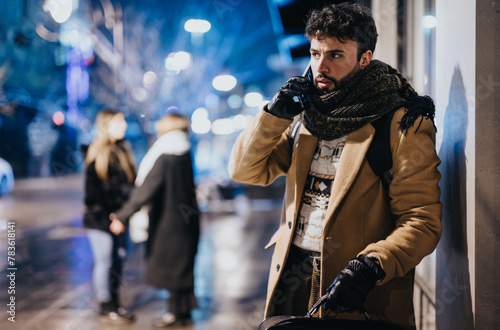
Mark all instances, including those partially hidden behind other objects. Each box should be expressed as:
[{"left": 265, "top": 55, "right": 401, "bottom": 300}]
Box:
[{"left": 83, "top": 144, "right": 134, "bottom": 232}]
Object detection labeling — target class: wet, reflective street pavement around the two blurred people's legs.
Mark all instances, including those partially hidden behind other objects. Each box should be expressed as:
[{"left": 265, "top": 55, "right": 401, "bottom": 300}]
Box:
[{"left": 0, "top": 176, "right": 281, "bottom": 330}]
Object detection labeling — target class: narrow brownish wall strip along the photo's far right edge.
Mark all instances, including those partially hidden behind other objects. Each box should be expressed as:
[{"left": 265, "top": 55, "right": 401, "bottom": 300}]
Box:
[{"left": 474, "top": 0, "right": 500, "bottom": 329}]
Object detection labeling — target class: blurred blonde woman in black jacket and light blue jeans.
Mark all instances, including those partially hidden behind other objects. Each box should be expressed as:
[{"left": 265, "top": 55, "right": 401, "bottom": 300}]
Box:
[{"left": 83, "top": 110, "right": 136, "bottom": 323}]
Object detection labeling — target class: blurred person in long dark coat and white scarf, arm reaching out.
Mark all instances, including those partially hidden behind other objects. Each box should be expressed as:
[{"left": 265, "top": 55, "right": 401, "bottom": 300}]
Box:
[{"left": 110, "top": 112, "right": 199, "bottom": 327}]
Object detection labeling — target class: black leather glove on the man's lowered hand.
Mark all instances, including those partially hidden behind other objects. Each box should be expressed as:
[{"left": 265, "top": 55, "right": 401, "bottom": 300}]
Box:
[{"left": 325, "top": 255, "right": 385, "bottom": 312}]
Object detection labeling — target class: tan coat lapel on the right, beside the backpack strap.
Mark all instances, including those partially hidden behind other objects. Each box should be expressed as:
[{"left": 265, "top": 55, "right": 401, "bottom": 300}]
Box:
[{"left": 326, "top": 124, "right": 375, "bottom": 222}]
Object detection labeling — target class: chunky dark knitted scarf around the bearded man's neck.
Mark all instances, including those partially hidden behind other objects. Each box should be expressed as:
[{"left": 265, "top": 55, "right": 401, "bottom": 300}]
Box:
[{"left": 301, "top": 60, "right": 435, "bottom": 140}]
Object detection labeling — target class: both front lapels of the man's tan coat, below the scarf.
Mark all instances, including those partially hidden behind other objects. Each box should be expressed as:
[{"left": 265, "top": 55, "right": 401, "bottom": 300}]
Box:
[{"left": 295, "top": 124, "right": 375, "bottom": 225}]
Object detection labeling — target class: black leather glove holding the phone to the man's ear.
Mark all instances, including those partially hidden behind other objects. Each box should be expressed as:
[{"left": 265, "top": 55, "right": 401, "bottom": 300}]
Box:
[{"left": 265, "top": 77, "right": 311, "bottom": 119}]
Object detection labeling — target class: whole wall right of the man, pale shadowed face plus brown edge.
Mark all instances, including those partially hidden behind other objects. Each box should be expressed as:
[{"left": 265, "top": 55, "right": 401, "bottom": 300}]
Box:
[{"left": 435, "top": 0, "right": 500, "bottom": 329}]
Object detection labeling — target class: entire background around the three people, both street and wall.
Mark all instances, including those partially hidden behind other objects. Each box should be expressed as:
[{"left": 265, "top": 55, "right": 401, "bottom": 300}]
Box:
[{"left": 0, "top": 0, "right": 500, "bottom": 330}]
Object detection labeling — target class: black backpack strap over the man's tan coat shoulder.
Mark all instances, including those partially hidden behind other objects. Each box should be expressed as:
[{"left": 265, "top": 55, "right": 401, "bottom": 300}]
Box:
[{"left": 366, "top": 111, "right": 395, "bottom": 190}]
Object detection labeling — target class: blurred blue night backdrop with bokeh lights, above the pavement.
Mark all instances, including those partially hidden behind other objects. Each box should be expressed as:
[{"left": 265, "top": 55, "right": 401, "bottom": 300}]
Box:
[{"left": 0, "top": 0, "right": 320, "bottom": 182}]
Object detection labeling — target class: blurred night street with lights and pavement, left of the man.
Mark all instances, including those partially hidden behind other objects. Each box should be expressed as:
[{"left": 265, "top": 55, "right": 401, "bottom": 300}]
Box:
[{"left": 0, "top": 0, "right": 308, "bottom": 329}]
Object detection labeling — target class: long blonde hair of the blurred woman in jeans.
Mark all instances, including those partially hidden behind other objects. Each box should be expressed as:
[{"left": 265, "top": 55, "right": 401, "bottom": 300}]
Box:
[{"left": 85, "top": 109, "right": 135, "bottom": 183}]
